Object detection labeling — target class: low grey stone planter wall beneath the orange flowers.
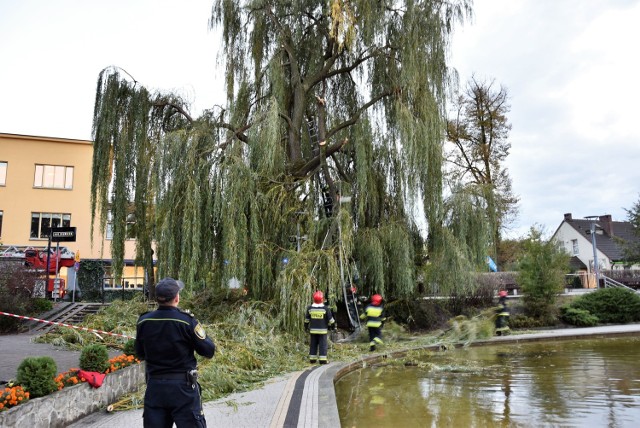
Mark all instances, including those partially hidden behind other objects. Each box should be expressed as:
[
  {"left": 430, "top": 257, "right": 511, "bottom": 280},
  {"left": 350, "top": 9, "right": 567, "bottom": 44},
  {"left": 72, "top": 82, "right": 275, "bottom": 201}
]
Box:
[{"left": 0, "top": 364, "right": 144, "bottom": 428}]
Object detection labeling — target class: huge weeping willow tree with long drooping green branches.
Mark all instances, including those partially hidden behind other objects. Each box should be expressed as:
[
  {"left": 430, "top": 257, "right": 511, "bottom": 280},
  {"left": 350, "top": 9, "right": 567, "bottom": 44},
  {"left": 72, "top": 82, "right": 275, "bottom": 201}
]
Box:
[{"left": 92, "top": 0, "right": 470, "bottom": 327}]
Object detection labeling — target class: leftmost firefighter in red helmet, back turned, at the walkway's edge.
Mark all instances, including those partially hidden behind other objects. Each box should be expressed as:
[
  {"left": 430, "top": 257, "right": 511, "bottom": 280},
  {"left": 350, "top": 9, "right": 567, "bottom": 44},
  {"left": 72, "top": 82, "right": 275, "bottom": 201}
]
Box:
[{"left": 304, "top": 291, "right": 336, "bottom": 364}]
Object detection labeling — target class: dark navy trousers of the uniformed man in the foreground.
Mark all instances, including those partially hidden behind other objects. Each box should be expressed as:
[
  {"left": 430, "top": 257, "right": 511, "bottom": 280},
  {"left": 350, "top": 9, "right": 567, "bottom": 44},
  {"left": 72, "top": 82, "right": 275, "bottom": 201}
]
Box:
[{"left": 142, "top": 374, "right": 207, "bottom": 428}]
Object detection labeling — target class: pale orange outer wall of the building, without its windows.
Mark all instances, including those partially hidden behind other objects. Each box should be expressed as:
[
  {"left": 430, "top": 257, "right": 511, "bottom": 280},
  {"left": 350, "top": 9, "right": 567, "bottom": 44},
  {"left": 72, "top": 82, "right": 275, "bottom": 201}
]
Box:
[{"left": 0, "top": 133, "right": 143, "bottom": 277}]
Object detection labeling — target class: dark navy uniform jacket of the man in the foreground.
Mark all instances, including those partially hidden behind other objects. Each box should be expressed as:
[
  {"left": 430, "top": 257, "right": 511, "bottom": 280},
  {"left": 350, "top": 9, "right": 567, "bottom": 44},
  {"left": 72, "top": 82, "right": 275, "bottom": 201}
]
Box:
[{"left": 135, "top": 306, "right": 216, "bottom": 375}]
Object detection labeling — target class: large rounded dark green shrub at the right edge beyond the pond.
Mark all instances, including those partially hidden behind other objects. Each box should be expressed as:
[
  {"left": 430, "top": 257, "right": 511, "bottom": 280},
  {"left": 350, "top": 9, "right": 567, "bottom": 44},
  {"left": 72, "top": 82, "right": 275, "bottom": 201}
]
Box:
[{"left": 570, "top": 288, "right": 640, "bottom": 324}]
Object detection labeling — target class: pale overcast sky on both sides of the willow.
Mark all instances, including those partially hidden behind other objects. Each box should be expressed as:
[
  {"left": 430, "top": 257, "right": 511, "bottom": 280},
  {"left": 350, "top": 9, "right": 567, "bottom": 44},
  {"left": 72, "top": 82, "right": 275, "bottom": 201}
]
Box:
[{"left": 0, "top": 0, "right": 640, "bottom": 237}]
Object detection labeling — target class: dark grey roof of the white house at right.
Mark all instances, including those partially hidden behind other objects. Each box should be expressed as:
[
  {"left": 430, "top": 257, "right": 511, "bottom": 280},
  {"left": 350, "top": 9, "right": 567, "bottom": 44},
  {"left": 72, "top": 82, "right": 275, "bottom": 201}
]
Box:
[{"left": 564, "top": 214, "right": 640, "bottom": 262}]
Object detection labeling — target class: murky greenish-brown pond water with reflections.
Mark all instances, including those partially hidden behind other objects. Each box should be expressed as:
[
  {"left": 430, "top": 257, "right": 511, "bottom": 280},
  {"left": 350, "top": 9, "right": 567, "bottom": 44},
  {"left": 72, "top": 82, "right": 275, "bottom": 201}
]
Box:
[{"left": 336, "top": 337, "right": 640, "bottom": 428}]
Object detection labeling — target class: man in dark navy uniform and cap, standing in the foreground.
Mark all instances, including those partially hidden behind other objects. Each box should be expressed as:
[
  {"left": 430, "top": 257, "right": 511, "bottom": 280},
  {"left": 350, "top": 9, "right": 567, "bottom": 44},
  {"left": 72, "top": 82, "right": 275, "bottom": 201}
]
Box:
[{"left": 135, "top": 278, "right": 216, "bottom": 428}]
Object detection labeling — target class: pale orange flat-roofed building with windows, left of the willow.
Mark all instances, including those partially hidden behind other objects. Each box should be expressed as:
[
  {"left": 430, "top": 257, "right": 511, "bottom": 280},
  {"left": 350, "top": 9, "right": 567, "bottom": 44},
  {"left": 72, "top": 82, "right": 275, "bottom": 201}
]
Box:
[{"left": 0, "top": 133, "right": 149, "bottom": 287}]
